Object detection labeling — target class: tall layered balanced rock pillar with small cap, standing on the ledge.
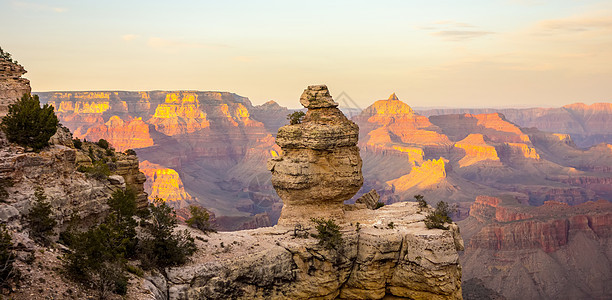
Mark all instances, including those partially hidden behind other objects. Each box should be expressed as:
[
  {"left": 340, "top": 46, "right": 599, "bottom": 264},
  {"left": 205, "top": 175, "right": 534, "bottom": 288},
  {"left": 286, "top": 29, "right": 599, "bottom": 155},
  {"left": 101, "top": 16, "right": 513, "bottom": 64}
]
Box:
[{"left": 268, "top": 85, "right": 363, "bottom": 225}]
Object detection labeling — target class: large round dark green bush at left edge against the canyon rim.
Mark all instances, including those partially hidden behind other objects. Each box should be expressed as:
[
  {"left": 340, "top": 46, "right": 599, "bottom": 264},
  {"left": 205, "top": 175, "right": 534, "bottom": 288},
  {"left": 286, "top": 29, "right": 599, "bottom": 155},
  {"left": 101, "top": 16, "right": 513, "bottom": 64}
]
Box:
[{"left": 0, "top": 94, "right": 59, "bottom": 151}]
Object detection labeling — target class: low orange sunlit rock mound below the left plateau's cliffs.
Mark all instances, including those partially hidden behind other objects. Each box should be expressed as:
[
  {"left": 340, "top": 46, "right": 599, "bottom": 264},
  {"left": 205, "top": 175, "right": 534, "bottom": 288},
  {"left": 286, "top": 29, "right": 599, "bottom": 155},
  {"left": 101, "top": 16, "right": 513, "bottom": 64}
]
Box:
[{"left": 80, "top": 116, "right": 153, "bottom": 151}]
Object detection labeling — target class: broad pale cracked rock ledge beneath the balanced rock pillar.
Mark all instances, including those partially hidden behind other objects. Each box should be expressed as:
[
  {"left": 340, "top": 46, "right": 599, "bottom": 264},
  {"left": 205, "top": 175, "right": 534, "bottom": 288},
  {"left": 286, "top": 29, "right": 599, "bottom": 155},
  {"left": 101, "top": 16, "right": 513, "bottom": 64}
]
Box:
[{"left": 143, "top": 202, "right": 463, "bottom": 299}]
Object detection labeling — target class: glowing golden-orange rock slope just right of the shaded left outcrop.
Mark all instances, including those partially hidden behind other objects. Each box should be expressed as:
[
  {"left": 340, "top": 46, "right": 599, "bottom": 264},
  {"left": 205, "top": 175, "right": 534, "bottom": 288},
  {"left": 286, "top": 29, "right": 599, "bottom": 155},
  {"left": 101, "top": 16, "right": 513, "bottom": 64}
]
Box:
[{"left": 140, "top": 160, "right": 192, "bottom": 202}]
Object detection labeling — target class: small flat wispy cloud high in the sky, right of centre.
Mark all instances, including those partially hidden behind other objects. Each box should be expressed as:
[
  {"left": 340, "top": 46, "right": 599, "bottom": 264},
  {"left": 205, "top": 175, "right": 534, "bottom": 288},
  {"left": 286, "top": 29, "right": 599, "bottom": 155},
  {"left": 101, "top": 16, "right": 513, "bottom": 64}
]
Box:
[{"left": 417, "top": 20, "right": 495, "bottom": 41}]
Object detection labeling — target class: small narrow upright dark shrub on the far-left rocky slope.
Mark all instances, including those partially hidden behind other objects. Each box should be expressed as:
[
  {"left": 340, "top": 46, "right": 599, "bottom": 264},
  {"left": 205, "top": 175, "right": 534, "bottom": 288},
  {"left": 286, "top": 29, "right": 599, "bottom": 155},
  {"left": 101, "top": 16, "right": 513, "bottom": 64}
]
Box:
[{"left": 25, "top": 188, "right": 57, "bottom": 246}]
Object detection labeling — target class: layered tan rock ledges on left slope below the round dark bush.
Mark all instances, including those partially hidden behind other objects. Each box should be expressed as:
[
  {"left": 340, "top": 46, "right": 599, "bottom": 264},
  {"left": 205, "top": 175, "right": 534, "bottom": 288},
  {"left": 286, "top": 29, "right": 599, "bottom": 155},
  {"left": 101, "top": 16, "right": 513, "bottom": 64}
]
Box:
[{"left": 0, "top": 145, "right": 147, "bottom": 229}]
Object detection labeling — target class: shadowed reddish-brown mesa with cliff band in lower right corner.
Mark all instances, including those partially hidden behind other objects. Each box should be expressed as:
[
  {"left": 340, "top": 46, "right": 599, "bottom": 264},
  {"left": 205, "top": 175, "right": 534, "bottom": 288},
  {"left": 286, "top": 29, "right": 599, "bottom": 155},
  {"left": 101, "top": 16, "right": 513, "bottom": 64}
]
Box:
[{"left": 459, "top": 196, "right": 612, "bottom": 299}]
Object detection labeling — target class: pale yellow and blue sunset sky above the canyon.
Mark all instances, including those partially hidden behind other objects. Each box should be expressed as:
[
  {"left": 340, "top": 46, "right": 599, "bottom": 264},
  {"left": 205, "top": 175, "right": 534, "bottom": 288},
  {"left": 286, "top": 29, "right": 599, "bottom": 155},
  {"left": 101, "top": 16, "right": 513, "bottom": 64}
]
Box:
[{"left": 0, "top": 0, "right": 612, "bottom": 108}]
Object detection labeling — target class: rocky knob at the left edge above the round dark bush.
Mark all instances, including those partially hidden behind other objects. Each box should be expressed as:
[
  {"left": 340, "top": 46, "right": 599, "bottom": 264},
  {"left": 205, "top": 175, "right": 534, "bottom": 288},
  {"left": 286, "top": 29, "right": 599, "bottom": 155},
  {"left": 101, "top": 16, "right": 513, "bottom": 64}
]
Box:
[{"left": 0, "top": 57, "right": 31, "bottom": 117}]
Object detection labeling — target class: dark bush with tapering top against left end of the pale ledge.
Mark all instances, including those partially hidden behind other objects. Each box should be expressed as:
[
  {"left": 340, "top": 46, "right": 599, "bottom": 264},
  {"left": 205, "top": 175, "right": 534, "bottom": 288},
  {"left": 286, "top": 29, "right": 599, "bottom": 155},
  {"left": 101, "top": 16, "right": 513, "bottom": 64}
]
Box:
[{"left": 139, "top": 198, "right": 197, "bottom": 270}]
